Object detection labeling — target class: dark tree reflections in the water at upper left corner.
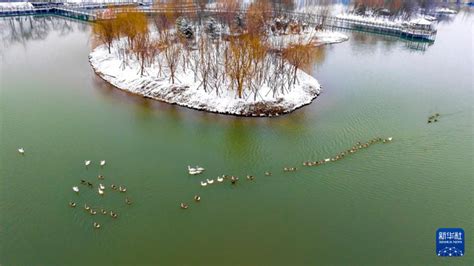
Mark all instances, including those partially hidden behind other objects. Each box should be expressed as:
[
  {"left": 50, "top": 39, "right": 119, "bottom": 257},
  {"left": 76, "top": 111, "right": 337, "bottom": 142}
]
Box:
[{"left": 0, "top": 16, "right": 87, "bottom": 51}]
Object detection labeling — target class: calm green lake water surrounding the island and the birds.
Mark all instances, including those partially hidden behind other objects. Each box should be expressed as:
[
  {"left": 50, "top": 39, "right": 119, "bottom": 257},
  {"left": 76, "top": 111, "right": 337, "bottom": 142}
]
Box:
[{"left": 0, "top": 13, "right": 474, "bottom": 265}]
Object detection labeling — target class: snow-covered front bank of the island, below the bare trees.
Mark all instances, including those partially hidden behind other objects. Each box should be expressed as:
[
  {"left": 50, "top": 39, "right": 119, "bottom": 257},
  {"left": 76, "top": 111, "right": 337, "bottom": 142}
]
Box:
[{"left": 89, "top": 32, "right": 348, "bottom": 117}]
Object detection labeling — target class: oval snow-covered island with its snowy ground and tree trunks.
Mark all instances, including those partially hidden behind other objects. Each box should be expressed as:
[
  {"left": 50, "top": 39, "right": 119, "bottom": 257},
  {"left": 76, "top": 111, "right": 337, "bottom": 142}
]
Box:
[{"left": 89, "top": 8, "right": 348, "bottom": 117}]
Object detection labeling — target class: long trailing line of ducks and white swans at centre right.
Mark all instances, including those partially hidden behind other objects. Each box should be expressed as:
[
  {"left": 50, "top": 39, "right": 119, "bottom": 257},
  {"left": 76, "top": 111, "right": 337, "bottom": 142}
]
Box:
[{"left": 180, "top": 137, "right": 393, "bottom": 209}]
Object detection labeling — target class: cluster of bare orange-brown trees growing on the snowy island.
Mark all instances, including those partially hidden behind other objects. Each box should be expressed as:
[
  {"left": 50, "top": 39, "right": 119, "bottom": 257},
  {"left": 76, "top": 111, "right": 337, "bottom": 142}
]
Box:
[{"left": 93, "top": 0, "right": 312, "bottom": 99}]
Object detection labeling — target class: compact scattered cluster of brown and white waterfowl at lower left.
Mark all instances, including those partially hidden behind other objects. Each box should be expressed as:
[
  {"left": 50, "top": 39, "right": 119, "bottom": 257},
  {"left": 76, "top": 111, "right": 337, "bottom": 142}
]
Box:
[{"left": 69, "top": 160, "right": 132, "bottom": 229}]
